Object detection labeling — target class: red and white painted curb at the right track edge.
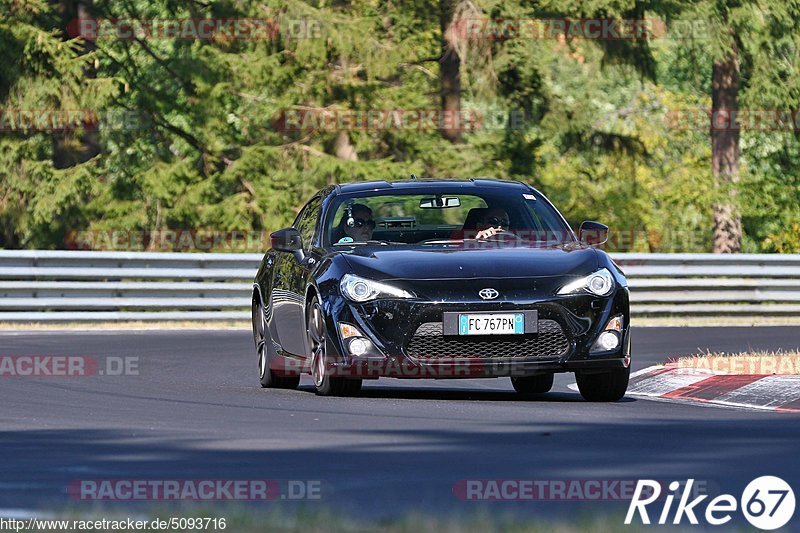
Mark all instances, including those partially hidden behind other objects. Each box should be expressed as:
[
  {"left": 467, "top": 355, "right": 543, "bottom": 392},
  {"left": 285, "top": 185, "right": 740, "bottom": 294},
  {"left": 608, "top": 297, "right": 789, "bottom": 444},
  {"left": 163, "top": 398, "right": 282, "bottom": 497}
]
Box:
[{"left": 627, "top": 365, "right": 800, "bottom": 413}]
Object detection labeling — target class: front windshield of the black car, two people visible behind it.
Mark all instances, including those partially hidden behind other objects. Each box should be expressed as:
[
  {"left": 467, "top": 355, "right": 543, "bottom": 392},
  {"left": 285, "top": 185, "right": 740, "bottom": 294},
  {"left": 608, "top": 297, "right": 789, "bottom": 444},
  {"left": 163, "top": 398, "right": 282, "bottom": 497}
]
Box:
[{"left": 323, "top": 189, "right": 574, "bottom": 246}]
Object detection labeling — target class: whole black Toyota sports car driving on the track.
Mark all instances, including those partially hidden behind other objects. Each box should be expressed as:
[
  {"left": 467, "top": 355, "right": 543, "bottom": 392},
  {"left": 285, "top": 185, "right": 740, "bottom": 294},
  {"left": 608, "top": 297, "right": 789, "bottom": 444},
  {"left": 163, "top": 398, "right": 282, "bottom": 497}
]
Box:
[{"left": 252, "top": 179, "right": 630, "bottom": 401}]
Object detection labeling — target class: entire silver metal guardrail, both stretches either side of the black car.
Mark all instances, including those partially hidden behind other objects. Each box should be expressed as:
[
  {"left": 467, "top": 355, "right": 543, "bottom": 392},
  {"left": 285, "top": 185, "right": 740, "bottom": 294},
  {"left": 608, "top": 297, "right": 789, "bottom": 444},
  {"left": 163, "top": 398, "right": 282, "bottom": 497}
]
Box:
[{"left": 0, "top": 250, "right": 800, "bottom": 322}]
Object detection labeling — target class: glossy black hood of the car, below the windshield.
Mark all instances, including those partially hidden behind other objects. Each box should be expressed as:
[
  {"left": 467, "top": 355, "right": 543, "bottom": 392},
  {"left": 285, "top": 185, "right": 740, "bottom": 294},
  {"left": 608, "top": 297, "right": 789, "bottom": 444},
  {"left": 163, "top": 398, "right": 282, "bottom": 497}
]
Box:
[{"left": 343, "top": 247, "right": 599, "bottom": 280}]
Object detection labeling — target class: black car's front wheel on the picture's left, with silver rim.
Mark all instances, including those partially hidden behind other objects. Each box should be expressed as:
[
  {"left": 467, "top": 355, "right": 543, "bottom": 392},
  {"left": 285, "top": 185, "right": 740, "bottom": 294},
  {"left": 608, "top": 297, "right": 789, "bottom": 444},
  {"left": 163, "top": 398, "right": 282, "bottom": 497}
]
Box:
[{"left": 306, "top": 296, "right": 361, "bottom": 396}]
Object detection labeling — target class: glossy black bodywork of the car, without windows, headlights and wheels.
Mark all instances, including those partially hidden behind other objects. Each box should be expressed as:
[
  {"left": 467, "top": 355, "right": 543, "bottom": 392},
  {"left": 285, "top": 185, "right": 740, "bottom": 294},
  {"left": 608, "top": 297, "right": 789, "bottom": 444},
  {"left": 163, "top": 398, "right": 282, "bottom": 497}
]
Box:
[{"left": 253, "top": 180, "right": 630, "bottom": 378}]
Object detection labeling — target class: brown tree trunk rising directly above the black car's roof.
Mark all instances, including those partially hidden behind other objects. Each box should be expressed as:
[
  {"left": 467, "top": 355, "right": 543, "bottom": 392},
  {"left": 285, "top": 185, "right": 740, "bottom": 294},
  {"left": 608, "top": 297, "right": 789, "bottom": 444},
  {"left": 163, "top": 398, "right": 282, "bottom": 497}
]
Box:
[{"left": 439, "top": 0, "right": 462, "bottom": 143}]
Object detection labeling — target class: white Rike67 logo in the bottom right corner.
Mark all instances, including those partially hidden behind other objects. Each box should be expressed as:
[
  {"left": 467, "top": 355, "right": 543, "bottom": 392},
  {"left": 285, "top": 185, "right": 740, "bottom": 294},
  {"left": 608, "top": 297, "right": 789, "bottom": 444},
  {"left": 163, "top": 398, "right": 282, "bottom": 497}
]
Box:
[{"left": 625, "top": 476, "right": 795, "bottom": 531}]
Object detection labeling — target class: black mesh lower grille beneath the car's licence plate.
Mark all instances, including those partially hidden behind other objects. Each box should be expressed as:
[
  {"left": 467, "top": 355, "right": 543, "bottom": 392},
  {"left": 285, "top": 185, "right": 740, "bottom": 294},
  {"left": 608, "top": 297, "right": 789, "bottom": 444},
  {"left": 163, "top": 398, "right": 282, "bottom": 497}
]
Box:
[{"left": 406, "top": 320, "right": 569, "bottom": 359}]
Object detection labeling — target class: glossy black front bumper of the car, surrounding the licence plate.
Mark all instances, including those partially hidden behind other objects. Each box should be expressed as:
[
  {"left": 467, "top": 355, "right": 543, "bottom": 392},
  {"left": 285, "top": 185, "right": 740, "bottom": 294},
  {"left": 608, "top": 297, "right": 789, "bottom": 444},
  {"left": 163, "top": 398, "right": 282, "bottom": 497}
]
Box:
[{"left": 322, "top": 281, "right": 630, "bottom": 378}]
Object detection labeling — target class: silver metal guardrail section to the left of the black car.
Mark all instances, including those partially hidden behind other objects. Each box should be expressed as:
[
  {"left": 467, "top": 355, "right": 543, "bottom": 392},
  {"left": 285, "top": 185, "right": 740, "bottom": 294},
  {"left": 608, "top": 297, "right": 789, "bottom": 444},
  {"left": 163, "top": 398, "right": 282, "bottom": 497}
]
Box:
[{"left": 0, "top": 250, "right": 262, "bottom": 322}]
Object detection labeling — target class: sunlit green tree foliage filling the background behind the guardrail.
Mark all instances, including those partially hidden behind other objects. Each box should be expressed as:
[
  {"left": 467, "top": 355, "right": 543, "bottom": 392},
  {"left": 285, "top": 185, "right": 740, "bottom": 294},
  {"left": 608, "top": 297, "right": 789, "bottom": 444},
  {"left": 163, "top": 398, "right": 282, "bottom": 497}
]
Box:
[{"left": 0, "top": 0, "right": 800, "bottom": 252}]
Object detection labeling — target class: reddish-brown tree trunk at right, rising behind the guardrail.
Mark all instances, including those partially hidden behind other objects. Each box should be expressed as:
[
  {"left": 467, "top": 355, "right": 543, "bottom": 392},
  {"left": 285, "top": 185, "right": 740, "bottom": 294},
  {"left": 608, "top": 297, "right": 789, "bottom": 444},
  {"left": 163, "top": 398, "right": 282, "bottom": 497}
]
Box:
[{"left": 711, "top": 47, "right": 742, "bottom": 253}]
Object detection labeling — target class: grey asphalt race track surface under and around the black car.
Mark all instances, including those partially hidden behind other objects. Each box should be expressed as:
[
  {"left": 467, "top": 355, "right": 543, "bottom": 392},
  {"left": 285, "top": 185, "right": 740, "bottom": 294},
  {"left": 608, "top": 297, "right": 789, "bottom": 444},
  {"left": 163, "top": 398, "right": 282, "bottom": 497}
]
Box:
[{"left": 0, "top": 327, "right": 800, "bottom": 525}]
